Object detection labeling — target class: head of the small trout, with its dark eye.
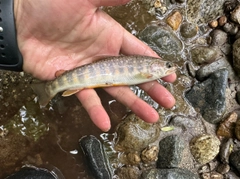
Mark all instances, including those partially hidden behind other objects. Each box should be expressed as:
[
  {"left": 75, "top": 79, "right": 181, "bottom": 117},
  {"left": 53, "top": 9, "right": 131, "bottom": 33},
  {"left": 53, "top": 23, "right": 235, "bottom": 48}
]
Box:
[{"left": 150, "top": 59, "right": 177, "bottom": 78}]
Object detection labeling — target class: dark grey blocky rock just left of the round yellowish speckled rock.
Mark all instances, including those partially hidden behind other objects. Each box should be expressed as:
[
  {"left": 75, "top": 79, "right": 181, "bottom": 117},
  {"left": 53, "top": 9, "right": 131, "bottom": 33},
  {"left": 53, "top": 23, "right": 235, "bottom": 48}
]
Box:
[{"left": 157, "top": 135, "right": 184, "bottom": 168}]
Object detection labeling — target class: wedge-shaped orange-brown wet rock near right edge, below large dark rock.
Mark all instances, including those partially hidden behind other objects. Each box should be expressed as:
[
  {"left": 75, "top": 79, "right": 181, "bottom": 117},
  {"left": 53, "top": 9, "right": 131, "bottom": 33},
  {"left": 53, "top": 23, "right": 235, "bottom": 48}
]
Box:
[{"left": 217, "top": 112, "right": 237, "bottom": 138}]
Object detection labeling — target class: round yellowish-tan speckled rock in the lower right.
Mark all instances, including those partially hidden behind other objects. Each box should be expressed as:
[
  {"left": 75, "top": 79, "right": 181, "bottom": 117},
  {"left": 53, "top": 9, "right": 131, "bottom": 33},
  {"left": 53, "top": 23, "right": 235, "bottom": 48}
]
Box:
[{"left": 190, "top": 134, "right": 220, "bottom": 164}]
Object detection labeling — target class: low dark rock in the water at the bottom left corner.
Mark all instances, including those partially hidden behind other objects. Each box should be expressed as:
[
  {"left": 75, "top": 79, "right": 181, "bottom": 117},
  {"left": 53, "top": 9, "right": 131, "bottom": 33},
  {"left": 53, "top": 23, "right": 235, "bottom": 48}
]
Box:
[{"left": 6, "top": 167, "right": 56, "bottom": 179}]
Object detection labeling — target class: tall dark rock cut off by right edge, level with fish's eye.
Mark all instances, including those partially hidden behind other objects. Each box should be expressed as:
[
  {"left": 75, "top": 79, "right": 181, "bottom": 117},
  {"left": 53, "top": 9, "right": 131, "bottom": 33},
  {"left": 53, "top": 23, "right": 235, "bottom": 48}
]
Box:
[{"left": 233, "top": 39, "right": 240, "bottom": 76}]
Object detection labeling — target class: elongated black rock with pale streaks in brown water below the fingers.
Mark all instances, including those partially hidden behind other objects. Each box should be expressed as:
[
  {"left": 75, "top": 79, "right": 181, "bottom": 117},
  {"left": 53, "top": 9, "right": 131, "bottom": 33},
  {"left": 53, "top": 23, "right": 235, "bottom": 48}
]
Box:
[{"left": 79, "top": 135, "right": 112, "bottom": 179}]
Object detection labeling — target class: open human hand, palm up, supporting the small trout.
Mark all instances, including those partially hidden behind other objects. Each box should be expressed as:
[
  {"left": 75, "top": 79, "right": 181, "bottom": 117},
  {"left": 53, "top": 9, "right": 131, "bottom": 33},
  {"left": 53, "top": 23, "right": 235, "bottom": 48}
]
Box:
[{"left": 14, "top": 0, "right": 176, "bottom": 131}]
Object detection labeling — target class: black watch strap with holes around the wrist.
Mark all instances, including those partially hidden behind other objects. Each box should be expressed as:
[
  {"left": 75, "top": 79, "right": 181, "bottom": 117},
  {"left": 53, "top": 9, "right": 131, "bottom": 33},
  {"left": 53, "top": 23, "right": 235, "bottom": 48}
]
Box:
[{"left": 0, "top": 0, "right": 23, "bottom": 71}]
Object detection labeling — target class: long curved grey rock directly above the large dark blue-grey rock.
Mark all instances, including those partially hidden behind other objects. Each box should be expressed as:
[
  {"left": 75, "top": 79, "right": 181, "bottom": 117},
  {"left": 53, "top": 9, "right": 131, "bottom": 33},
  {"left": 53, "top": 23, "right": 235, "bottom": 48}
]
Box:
[{"left": 196, "top": 58, "right": 234, "bottom": 81}]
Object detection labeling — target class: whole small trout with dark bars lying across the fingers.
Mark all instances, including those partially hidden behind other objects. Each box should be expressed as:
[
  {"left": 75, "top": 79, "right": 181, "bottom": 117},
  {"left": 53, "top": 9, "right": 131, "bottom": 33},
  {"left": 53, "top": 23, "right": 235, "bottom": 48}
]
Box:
[{"left": 32, "top": 56, "right": 176, "bottom": 106}]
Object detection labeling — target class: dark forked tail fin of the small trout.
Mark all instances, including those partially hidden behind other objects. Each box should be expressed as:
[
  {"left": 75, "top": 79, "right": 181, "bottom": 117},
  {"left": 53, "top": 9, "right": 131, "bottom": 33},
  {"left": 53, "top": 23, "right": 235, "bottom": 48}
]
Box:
[{"left": 31, "top": 82, "right": 53, "bottom": 107}]
